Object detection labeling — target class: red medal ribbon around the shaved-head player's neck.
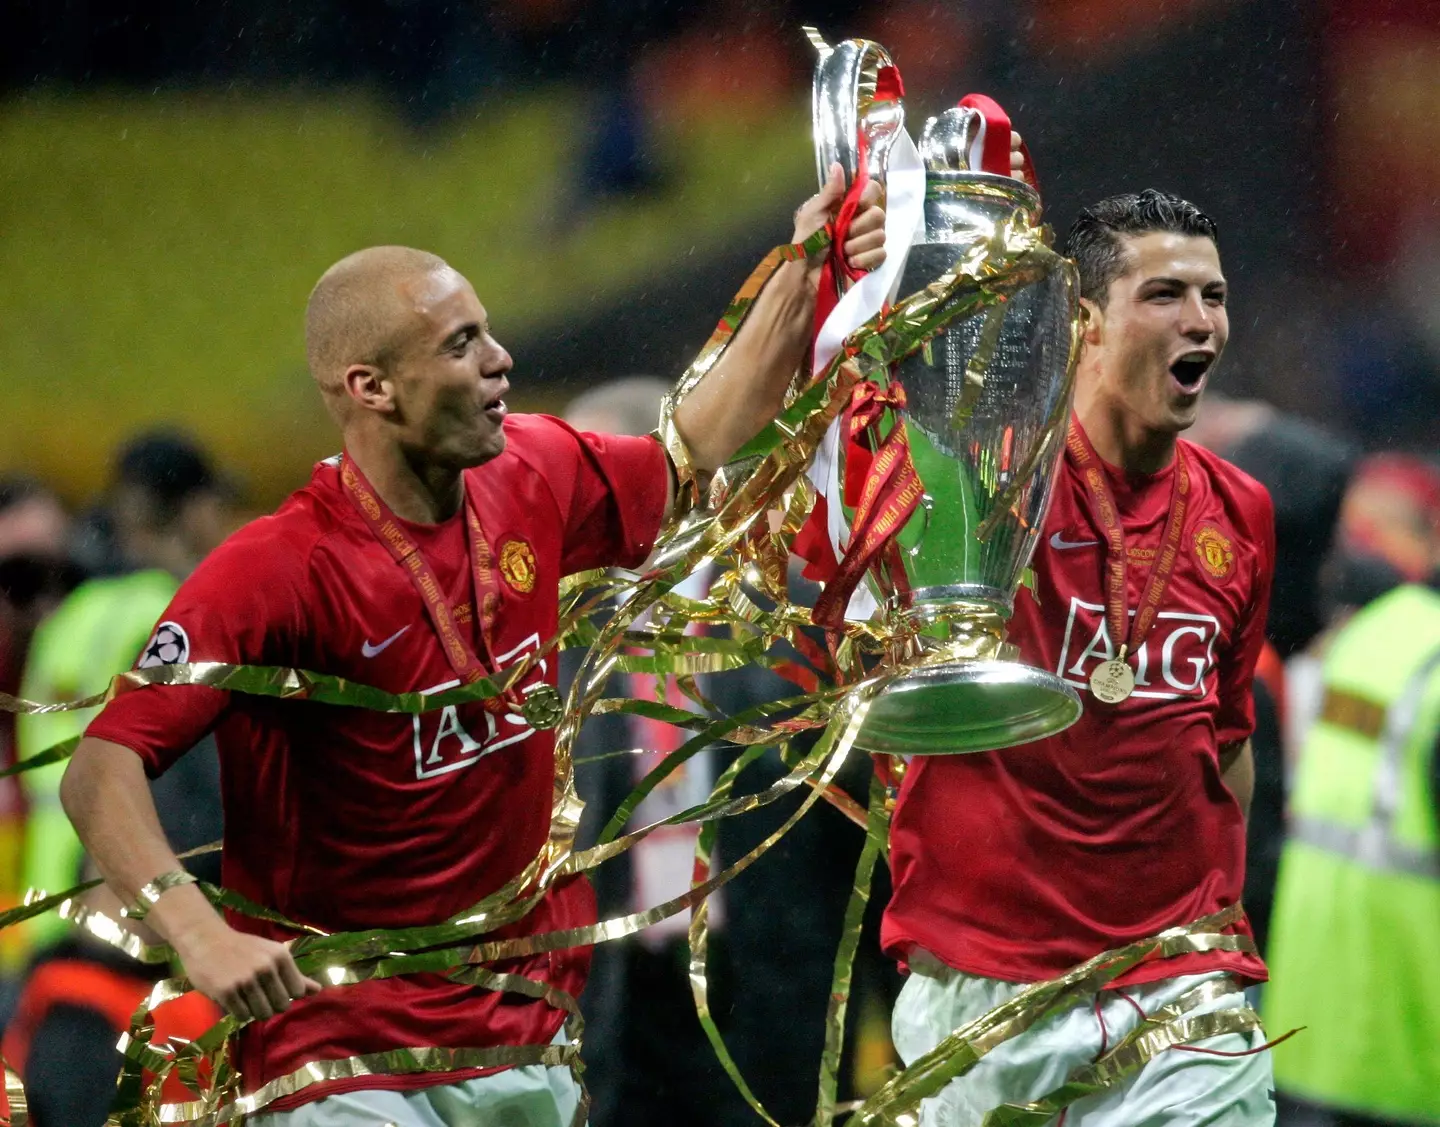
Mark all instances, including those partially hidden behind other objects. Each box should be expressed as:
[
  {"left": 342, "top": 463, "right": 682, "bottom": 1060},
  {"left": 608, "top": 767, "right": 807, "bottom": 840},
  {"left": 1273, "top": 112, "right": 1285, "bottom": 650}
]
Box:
[{"left": 340, "top": 453, "right": 520, "bottom": 714}]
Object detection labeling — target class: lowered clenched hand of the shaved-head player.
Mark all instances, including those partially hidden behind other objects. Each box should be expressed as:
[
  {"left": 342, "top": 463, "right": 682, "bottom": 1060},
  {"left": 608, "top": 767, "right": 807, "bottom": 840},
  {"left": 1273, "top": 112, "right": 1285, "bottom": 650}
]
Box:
[{"left": 176, "top": 920, "right": 321, "bottom": 1020}]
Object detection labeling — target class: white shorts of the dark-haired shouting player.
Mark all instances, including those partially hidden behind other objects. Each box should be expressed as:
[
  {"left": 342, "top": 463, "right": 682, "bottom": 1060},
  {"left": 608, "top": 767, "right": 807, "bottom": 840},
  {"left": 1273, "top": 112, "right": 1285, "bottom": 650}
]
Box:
[{"left": 891, "top": 967, "right": 1274, "bottom": 1127}]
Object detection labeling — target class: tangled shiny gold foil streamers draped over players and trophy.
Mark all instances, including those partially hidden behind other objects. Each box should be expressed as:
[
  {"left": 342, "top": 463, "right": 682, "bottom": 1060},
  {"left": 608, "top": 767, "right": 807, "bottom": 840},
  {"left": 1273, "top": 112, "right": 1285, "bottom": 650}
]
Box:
[{"left": 0, "top": 208, "right": 1226, "bottom": 1127}]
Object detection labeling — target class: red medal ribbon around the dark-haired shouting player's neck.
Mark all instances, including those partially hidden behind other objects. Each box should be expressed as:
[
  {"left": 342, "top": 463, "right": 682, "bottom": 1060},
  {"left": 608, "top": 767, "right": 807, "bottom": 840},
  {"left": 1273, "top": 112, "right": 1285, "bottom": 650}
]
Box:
[{"left": 1066, "top": 419, "right": 1189, "bottom": 661}]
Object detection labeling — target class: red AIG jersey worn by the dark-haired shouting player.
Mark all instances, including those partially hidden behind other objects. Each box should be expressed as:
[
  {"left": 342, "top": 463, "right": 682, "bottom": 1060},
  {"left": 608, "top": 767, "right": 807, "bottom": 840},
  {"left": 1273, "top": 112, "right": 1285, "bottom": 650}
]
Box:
[{"left": 881, "top": 423, "right": 1274, "bottom": 983}]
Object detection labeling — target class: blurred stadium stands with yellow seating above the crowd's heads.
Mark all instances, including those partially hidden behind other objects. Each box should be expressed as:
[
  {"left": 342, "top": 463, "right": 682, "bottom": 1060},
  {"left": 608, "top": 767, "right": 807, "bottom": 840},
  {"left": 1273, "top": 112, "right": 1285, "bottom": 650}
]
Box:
[{"left": 0, "top": 0, "right": 1440, "bottom": 508}]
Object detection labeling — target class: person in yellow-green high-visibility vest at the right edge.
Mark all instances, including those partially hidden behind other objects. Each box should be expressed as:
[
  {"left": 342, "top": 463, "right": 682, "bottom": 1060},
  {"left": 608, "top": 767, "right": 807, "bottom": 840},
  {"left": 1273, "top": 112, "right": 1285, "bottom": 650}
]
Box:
[{"left": 1263, "top": 455, "right": 1440, "bottom": 1127}]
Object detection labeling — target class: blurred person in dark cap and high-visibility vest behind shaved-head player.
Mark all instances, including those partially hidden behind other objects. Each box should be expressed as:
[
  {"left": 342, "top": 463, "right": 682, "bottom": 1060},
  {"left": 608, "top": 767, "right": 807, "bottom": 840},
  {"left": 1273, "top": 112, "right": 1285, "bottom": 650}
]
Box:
[{"left": 16, "top": 432, "right": 229, "bottom": 946}]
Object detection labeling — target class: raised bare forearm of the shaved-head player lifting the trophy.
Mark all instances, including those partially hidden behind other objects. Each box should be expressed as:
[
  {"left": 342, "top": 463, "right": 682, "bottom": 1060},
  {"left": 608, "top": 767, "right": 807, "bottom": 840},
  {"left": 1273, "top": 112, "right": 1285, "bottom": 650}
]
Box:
[{"left": 675, "top": 262, "right": 815, "bottom": 472}]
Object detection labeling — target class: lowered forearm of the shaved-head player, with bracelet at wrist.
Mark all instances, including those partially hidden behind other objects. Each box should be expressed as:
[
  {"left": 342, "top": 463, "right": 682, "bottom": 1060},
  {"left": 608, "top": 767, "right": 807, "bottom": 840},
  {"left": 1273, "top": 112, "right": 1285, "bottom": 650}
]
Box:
[{"left": 60, "top": 738, "right": 220, "bottom": 947}]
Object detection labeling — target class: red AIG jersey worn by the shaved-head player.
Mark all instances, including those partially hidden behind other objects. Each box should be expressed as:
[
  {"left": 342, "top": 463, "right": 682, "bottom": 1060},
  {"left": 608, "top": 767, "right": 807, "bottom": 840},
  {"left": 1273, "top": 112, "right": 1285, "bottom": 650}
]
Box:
[{"left": 89, "top": 416, "right": 668, "bottom": 1108}]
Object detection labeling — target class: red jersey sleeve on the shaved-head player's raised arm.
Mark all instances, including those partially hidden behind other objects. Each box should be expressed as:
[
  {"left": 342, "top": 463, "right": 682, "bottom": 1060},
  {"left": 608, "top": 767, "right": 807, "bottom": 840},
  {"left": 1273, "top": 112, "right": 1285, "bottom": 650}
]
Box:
[{"left": 509, "top": 415, "right": 670, "bottom": 576}]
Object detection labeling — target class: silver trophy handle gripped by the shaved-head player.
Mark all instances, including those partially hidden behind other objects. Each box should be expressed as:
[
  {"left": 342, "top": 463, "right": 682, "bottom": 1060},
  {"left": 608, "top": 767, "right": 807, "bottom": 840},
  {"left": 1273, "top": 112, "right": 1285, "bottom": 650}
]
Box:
[{"left": 804, "top": 27, "right": 904, "bottom": 187}]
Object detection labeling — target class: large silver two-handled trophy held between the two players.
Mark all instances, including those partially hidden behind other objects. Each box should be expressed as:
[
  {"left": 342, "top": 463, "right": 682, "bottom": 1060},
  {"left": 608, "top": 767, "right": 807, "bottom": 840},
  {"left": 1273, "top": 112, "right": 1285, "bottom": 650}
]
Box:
[{"left": 806, "top": 29, "right": 1080, "bottom": 754}]
